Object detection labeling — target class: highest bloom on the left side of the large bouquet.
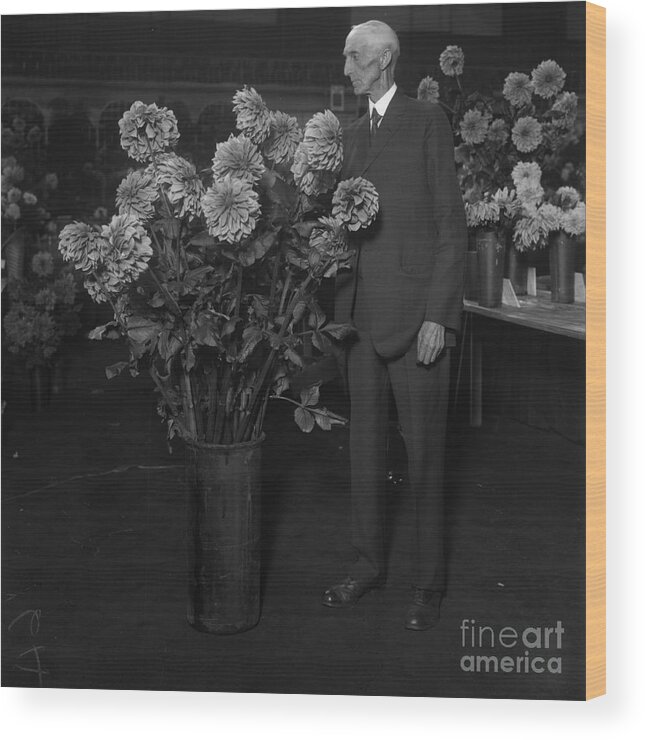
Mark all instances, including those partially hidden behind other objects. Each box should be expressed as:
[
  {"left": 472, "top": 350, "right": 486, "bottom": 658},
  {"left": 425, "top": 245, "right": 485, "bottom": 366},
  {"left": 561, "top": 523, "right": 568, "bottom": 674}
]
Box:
[{"left": 119, "top": 100, "right": 179, "bottom": 162}]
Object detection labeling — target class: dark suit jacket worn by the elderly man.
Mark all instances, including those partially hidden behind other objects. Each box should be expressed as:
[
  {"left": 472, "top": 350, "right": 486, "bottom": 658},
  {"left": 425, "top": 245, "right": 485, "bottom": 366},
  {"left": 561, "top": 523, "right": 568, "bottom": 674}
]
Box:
[{"left": 336, "top": 89, "right": 467, "bottom": 358}]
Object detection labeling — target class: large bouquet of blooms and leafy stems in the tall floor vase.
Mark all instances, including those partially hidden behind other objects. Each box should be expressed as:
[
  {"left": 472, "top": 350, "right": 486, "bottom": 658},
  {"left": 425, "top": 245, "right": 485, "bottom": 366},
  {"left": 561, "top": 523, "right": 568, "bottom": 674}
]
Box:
[{"left": 59, "top": 88, "right": 378, "bottom": 444}]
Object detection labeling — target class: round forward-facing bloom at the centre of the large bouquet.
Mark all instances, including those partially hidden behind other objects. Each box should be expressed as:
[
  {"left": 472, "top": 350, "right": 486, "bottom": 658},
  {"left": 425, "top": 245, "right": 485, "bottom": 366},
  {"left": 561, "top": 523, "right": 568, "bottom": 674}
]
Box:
[{"left": 202, "top": 175, "right": 260, "bottom": 244}]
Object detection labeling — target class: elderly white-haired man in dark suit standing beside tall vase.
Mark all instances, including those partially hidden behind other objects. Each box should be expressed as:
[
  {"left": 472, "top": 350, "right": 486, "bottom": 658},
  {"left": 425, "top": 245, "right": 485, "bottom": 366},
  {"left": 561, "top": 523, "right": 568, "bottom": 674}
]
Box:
[{"left": 323, "top": 21, "right": 467, "bottom": 630}]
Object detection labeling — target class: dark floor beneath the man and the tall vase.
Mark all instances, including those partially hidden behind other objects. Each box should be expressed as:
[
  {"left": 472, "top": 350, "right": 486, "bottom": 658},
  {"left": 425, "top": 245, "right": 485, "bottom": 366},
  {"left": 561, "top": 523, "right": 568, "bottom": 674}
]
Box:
[{"left": 2, "top": 340, "right": 585, "bottom": 699}]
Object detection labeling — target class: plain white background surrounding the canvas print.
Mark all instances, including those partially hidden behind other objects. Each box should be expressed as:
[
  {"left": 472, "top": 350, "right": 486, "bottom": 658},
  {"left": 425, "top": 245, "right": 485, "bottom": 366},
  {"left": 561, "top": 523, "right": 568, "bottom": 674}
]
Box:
[{"left": 0, "top": 0, "right": 645, "bottom": 740}]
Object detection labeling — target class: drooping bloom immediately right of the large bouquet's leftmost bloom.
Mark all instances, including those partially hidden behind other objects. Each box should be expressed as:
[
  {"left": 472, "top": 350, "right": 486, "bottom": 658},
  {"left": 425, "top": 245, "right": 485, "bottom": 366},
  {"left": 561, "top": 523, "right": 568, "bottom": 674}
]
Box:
[{"left": 101, "top": 215, "right": 152, "bottom": 292}]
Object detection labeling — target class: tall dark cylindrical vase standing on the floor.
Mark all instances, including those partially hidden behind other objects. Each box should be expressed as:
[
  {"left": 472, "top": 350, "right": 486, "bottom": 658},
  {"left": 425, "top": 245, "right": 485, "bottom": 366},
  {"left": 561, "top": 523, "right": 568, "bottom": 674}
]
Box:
[{"left": 186, "top": 436, "right": 264, "bottom": 635}]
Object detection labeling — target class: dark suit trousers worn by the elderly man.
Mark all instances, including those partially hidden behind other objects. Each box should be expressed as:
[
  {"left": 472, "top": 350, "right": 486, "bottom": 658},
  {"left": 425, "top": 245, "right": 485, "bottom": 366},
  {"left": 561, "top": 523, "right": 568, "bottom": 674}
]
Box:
[{"left": 347, "top": 330, "right": 450, "bottom": 591}]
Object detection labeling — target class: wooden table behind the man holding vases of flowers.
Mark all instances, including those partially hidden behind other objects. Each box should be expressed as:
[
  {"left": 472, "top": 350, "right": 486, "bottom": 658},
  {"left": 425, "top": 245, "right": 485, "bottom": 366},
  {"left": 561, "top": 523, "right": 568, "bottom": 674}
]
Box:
[{"left": 457, "top": 290, "right": 586, "bottom": 427}]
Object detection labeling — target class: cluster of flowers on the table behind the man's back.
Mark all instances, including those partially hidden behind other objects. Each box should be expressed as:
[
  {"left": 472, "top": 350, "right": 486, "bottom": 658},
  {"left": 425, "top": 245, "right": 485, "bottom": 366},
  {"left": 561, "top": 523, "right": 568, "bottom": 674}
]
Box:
[{"left": 417, "top": 46, "right": 580, "bottom": 251}]
